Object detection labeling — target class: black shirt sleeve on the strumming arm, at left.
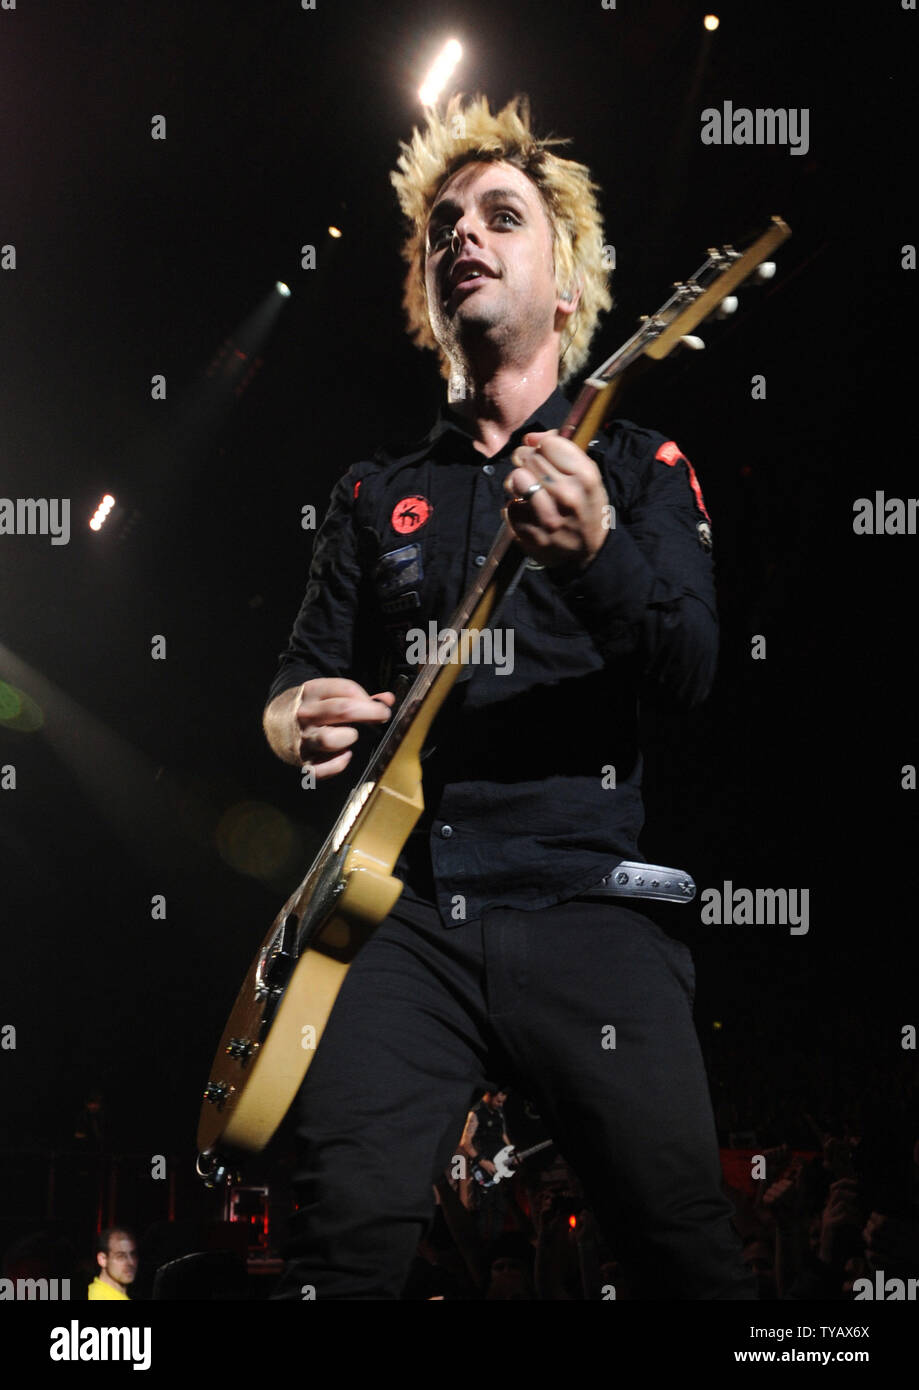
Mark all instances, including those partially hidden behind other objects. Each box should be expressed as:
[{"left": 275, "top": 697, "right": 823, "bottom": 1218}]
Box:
[{"left": 266, "top": 464, "right": 361, "bottom": 703}]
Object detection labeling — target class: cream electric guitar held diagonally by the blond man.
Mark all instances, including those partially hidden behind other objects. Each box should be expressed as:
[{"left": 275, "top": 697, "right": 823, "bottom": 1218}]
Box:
[{"left": 197, "top": 217, "right": 791, "bottom": 1183}]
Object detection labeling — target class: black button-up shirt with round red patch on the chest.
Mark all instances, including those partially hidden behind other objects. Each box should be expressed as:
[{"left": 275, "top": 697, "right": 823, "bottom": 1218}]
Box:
[{"left": 268, "top": 389, "right": 717, "bottom": 926}]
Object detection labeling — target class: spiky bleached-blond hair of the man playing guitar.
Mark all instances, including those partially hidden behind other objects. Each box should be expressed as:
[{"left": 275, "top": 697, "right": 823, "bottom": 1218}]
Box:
[{"left": 389, "top": 93, "right": 613, "bottom": 384}]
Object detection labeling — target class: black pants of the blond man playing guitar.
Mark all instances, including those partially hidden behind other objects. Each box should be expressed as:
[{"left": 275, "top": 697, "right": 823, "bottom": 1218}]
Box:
[{"left": 275, "top": 894, "right": 756, "bottom": 1298}]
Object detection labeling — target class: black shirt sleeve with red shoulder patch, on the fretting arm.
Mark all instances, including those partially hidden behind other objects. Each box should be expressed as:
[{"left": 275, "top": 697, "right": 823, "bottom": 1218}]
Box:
[{"left": 549, "top": 436, "right": 717, "bottom": 708}]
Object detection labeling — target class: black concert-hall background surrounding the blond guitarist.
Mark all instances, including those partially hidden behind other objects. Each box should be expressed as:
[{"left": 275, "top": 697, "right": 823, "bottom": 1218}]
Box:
[{"left": 0, "top": 0, "right": 919, "bottom": 1251}]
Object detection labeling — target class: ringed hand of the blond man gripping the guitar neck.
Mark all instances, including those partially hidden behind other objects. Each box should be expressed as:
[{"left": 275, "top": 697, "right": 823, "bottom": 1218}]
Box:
[{"left": 505, "top": 430, "right": 612, "bottom": 570}]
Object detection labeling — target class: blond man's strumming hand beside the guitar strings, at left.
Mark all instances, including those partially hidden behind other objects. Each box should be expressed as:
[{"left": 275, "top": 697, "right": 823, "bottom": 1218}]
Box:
[{"left": 263, "top": 676, "right": 396, "bottom": 781}]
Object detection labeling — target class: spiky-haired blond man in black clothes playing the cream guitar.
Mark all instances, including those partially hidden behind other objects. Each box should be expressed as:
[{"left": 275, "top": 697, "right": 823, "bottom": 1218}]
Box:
[{"left": 264, "top": 97, "right": 755, "bottom": 1298}]
